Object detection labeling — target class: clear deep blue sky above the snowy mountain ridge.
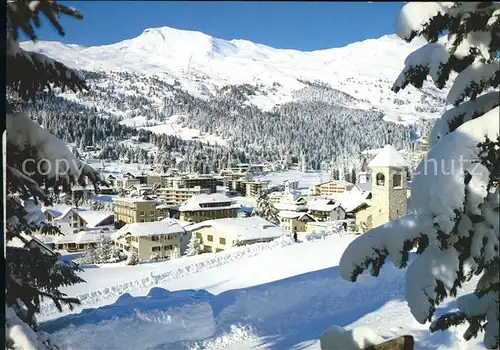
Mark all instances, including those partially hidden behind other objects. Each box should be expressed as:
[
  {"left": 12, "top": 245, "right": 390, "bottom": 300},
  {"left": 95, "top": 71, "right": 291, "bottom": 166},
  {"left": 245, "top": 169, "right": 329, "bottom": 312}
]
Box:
[{"left": 25, "top": 1, "right": 404, "bottom": 51}]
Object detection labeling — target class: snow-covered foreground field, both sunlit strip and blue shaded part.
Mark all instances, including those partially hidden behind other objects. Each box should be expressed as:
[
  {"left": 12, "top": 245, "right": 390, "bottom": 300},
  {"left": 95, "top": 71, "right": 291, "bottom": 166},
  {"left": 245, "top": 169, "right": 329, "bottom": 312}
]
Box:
[{"left": 40, "top": 235, "right": 481, "bottom": 349}]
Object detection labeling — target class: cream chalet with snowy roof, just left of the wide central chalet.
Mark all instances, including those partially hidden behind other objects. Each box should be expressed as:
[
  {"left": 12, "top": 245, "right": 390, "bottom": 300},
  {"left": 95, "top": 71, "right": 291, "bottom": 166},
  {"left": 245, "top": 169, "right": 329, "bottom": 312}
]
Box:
[{"left": 112, "top": 218, "right": 191, "bottom": 260}]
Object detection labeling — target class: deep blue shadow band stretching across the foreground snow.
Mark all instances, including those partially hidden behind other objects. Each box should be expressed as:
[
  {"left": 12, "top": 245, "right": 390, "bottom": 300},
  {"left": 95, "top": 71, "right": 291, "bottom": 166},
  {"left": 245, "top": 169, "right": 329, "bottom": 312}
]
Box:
[{"left": 41, "top": 264, "right": 450, "bottom": 349}]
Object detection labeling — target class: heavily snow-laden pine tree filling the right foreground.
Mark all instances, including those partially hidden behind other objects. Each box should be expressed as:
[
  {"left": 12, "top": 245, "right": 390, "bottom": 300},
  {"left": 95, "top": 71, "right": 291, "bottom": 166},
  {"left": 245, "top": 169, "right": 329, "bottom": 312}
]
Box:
[{"left": 340, "top": 1, "right": 500, "bottom": 349}]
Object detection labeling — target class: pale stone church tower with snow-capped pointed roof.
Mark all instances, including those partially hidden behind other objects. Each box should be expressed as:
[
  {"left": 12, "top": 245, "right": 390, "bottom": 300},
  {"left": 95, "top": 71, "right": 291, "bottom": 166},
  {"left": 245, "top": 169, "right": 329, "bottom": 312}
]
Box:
[{"left": 368, "top": 145, "right": 408, "bottom": 227}]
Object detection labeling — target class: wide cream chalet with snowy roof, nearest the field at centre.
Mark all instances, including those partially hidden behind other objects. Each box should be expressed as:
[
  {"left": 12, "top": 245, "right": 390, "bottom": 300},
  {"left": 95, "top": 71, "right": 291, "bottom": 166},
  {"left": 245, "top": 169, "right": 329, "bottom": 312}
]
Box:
[{"left": 189, "top": 216, "right": 286, "bottom": 253}]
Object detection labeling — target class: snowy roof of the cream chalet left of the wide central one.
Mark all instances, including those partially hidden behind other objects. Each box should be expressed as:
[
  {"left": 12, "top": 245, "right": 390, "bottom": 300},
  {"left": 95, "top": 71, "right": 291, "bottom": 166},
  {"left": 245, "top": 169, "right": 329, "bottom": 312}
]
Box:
[{"left": 113, "top": 218, "right": 185, "bottom": 239}]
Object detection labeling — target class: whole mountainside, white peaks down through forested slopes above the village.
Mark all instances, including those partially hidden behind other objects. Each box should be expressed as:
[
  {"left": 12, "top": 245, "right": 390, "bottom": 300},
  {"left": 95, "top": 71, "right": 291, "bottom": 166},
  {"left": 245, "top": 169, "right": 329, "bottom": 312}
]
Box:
[{"left": 21, "top": 27, "right": 448, "bottom": 173}]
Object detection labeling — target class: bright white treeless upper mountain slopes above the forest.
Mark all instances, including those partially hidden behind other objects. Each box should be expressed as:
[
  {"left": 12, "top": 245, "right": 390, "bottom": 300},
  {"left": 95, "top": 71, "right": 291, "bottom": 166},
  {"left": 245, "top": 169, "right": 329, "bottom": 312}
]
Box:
[{"left": 21, "top": 27, "right": 445, "bottom": 123}]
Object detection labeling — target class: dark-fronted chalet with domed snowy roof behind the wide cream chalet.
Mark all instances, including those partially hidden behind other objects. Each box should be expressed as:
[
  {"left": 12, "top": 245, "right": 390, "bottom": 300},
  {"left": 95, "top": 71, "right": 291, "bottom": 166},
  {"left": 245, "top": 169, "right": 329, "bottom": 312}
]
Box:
[{"left": 178, "top": 193, "right": 240, "bottom": 223}]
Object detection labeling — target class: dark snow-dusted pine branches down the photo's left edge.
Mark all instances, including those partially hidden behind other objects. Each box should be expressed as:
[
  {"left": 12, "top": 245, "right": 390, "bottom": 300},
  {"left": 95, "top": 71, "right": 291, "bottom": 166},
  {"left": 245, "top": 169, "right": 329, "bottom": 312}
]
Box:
[{"left": 2, "top": 0, "right": 98, "bottom": 349}]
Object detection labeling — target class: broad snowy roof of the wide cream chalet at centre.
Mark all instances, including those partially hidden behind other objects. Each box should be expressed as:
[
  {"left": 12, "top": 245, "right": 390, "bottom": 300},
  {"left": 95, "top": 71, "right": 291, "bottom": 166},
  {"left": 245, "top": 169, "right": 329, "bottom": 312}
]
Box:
[{"left": 187, "top": 216, "right": 285, "bottom": 242}]
